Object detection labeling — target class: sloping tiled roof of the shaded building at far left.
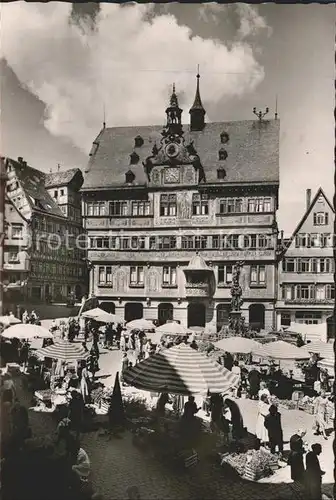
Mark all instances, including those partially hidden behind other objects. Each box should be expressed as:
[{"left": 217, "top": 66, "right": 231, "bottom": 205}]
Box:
[{"left": 9, "top": 159, "right": 64, "bottom": 217}]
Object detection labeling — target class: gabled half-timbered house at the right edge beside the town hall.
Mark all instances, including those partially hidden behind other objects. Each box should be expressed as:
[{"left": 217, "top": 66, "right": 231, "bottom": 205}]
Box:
[{"left": 276, "top": 189, "right": 335, "bottom": 340}]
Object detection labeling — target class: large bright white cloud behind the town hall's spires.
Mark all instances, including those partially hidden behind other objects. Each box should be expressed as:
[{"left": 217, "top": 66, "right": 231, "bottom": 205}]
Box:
[{"left": 1, "top": 2, "right": 264, "bottom": 152}]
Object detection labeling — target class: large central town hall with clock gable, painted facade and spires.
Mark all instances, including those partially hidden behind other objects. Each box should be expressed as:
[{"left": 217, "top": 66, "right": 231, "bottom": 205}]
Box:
[{"left": 82, "top": 76, "right": 279, "bottom": 331}]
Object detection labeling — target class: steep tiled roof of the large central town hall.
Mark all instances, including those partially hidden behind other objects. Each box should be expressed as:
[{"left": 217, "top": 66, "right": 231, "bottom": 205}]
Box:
[{"left": 83, "top": 120, "right": 280, "bottom": 189}]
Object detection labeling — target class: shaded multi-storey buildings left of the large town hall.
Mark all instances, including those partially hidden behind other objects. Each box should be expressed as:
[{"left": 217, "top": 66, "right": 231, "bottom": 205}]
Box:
[{"left": 4, "top": 158, "right": 87, "bottom": 305}]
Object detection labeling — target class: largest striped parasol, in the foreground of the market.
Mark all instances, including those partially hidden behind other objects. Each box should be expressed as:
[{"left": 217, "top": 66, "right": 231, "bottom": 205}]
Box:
[{"left": 123, "top": 344, "right": 239, "bottom": 395}]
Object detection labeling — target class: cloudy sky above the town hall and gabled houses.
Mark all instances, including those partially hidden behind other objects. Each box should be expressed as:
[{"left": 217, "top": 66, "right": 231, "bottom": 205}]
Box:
[{"left": 0, "top": 2, "right": 335, "bottom": 235}]
